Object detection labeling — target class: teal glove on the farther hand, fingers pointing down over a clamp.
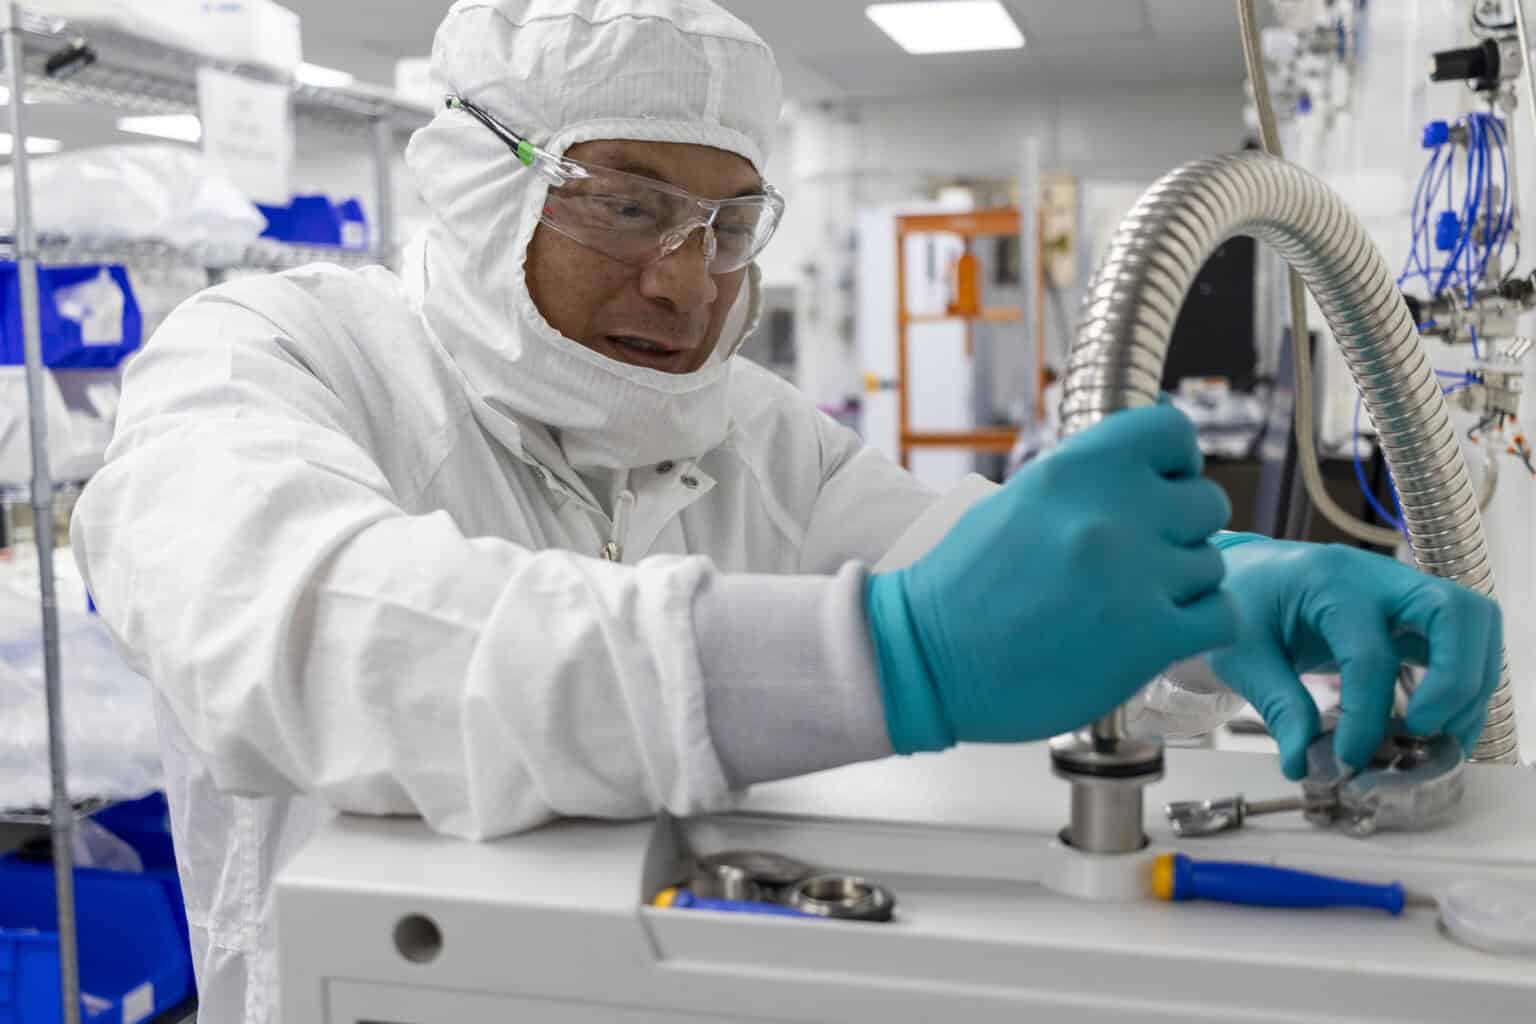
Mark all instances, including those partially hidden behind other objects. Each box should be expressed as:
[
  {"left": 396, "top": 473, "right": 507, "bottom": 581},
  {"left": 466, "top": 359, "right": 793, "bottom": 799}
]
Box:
[{"left": 1209, "top": 533, "right": 1504, "bottom": 778}]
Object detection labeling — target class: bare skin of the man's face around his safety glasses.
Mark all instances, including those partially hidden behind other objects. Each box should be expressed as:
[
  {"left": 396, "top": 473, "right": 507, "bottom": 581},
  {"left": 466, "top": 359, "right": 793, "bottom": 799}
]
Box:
[{"left": 527, "top": 140, "right": 762, "bottom": 373}]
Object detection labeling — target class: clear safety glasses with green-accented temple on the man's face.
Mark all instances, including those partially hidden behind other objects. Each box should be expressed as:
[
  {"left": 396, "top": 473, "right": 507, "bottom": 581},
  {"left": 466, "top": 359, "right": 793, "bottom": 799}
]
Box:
[{"left": 447, "top": 95, "right": 783, "bottom": 275}]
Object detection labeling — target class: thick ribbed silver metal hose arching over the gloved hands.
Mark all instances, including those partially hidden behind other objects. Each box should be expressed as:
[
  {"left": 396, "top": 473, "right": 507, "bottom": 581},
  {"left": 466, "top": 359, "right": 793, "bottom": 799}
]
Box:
[{"left": 1061, "top": 154, "right": 1518, "bottom": 761}]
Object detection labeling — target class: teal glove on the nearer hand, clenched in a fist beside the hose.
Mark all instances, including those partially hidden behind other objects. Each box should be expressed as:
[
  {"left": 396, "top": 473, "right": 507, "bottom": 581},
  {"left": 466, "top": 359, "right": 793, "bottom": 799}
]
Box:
[{"left": 865, "top": 405, "right": 1236, "bottom": 754}]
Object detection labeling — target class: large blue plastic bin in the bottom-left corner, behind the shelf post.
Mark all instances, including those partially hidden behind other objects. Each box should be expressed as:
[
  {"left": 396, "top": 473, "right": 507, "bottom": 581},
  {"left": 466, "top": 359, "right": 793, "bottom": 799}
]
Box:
[{"left": 0, "top": 860, "right": 192, "bottom": 1024}]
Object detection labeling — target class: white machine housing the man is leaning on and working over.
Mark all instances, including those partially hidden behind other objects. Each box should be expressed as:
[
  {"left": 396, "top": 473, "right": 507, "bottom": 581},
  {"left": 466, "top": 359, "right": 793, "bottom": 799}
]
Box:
[{"left": 276, "top": 745, "right": 1536, "bottom": 1024}]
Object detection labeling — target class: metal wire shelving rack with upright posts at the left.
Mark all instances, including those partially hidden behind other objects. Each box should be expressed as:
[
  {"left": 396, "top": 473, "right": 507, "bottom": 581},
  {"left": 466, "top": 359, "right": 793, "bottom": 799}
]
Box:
[{"left": 0, "top": 0, "right": 430, "bottom": 1024}]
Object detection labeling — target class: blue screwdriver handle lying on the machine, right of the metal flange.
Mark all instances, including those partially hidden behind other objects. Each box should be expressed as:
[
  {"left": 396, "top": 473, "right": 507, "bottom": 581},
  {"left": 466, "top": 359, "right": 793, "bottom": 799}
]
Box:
[{"left": 1174, "top": 854, "right": 1405, "bottom": 915}]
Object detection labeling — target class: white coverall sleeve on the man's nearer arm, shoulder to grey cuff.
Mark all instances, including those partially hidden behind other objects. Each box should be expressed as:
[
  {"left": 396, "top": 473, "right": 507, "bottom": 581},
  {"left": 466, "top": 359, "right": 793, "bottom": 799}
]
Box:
[{"left": 72, "top": 292, "right": 752, "bottom": 838}]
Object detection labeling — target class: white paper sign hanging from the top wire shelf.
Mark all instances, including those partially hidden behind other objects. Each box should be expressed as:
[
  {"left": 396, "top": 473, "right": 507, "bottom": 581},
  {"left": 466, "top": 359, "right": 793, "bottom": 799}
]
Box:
[{"left": 197, "top": 68, "right": 293, "bottom": 206}]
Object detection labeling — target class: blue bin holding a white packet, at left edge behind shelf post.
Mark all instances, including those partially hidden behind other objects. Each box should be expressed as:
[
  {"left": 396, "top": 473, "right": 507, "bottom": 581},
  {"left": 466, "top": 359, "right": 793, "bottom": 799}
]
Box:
[{"left": 0, "top": 263, "right": 144, "bottom": 370}]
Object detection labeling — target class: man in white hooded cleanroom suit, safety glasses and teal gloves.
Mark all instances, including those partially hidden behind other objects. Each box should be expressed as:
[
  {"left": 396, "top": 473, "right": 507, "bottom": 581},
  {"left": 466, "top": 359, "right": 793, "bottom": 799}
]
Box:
[{"left": 72, "top": 0, "right": 1499, "bottom": 1024}]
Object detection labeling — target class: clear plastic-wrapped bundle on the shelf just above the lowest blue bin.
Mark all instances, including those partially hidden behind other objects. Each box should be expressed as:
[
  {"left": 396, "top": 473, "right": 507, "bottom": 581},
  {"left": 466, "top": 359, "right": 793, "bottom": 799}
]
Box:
[{"left": 0, "top": 579, "right": 161, "bottom": 811}]
